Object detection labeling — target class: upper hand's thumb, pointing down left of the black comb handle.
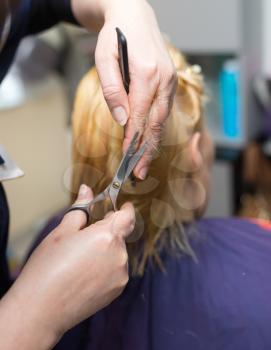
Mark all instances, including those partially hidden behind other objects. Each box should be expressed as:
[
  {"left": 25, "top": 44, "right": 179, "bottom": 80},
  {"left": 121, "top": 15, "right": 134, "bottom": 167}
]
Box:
[{"left": 95, "top": 29, "right": 129, "bottom": 126}]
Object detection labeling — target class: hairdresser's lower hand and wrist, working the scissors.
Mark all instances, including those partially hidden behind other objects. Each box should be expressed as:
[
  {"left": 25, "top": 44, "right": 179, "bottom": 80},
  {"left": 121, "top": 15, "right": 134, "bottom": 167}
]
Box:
[{"left": 0, "top": 186, "right": 135, "bottom": 350}]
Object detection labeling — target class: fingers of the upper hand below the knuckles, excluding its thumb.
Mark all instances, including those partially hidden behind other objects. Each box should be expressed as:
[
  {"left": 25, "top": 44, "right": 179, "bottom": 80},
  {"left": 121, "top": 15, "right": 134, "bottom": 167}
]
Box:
[{"left": 124, "top": 63, "right": 176, "bottom": 180}]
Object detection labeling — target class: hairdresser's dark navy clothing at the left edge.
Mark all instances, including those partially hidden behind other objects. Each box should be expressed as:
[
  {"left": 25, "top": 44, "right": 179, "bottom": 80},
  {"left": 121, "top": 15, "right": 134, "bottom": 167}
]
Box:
[{"left": 0, "top": 0, "right": 76, "bottom": 297}]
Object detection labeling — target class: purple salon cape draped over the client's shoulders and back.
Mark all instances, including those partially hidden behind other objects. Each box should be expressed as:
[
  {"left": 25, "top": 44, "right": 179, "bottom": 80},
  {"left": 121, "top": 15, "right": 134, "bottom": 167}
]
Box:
[{"left": 30, "top": 217, "right": 271, "bottom": 350}]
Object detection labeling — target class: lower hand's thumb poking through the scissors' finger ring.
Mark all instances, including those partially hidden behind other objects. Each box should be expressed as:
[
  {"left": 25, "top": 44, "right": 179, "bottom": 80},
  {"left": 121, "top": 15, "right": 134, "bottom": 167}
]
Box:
[{"left": 61, "top": 185, "right": 93, "bottom": 232}]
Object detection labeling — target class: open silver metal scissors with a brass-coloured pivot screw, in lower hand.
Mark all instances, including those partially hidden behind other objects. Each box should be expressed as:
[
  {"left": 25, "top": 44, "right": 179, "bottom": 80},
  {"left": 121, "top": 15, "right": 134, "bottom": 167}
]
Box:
[{"left": 67, "top": 132, "right": 147, "bottom": 222}]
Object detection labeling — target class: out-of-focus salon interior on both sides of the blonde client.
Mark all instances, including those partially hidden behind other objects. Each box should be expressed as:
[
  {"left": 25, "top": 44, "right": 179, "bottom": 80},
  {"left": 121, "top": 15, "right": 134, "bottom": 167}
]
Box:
[{"left": 0, "top": 0, "right": 271, "bottom": 267}]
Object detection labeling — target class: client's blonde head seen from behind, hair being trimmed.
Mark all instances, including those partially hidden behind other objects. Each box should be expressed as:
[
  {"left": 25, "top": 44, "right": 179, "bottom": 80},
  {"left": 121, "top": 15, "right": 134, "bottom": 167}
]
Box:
[{"left": 72, "top": 42, "right": 213, "bottom": 274}]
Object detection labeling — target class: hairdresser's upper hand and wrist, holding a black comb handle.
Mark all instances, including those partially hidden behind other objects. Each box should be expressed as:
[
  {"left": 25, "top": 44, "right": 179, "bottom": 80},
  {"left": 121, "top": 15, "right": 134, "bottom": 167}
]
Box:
[{"left": 72, "top": 0, "right": 176, "bottom": 179}]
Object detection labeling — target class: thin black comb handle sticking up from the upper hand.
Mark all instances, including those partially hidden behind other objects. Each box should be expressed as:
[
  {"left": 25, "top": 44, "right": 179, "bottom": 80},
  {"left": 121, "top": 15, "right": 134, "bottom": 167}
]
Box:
[{"left": 116, "top": 28, "right": 130, "bottom": 94}]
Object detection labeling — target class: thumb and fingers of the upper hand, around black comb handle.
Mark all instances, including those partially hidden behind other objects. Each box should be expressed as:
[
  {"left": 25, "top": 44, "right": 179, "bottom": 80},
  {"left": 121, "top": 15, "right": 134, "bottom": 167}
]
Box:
[{"left": 95, "top": 24, "right": 176, "bottom": 180}]
